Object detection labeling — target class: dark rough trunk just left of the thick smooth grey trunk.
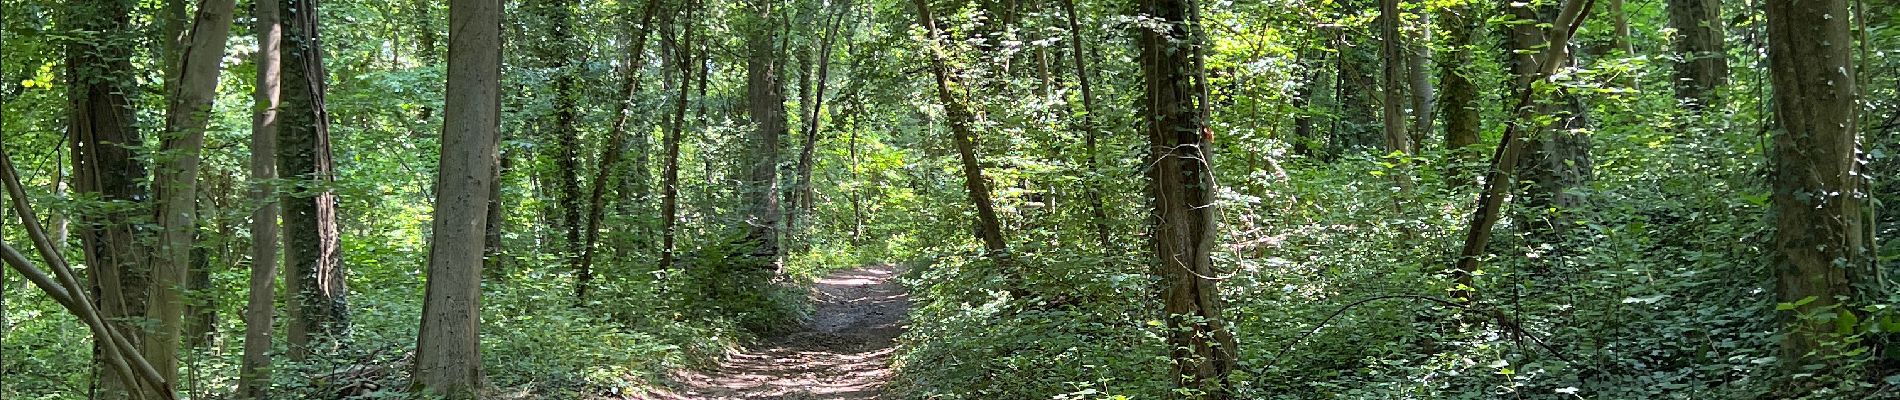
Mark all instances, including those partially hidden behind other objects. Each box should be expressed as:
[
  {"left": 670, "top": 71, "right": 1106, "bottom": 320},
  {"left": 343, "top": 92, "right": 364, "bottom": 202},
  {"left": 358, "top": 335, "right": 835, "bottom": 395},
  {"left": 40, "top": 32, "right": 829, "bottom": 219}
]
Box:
[{"left": 277, "top": 0, "right": 350, "bottom": 360}]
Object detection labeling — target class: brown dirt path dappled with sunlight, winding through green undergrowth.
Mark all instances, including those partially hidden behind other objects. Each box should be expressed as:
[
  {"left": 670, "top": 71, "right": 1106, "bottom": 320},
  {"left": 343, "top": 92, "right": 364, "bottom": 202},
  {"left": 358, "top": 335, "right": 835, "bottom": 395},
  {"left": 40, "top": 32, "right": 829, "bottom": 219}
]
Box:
[{"left": 675, "top": 265, "right": 910, "bottom": 400}]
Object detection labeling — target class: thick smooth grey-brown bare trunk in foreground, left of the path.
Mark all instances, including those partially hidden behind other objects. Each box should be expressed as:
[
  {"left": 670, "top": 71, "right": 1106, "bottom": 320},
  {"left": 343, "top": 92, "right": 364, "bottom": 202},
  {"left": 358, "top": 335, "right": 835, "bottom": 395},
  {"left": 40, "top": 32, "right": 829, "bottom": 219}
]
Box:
[{"left": 414, "top": 0, "right": 502, "bottom": 398}]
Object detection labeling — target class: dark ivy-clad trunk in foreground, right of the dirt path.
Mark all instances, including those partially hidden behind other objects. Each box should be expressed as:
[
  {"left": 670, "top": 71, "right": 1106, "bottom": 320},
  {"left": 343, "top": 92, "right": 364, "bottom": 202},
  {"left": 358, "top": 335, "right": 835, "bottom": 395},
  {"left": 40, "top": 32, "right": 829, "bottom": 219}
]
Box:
[{"left": 1138, "top": 0, "right": 1237, "bottom": 400}]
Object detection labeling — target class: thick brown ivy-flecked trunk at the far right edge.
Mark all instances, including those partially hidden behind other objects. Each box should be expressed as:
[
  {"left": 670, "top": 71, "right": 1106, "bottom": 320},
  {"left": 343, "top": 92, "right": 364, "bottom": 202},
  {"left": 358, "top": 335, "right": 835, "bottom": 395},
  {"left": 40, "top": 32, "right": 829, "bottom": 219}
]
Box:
[{"left": 1767, "top": 0, "right": 1887, "bottom": 368}]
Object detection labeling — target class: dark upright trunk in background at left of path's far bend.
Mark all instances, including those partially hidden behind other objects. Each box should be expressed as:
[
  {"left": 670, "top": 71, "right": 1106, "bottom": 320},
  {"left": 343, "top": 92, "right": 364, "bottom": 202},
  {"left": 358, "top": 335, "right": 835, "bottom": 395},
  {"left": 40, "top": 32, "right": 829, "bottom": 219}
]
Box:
[{"left": 745, "top": 0, "right": 787, "bottom": 264}]
